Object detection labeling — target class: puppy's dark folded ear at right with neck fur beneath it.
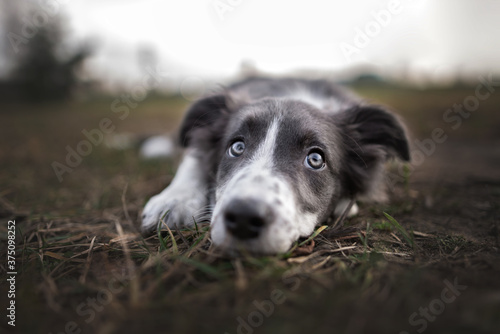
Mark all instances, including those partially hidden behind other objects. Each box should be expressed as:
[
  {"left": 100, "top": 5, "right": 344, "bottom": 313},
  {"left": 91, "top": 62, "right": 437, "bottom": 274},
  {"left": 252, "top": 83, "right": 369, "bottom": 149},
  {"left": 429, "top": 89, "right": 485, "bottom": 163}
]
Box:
[{"left": 339, "top": 105, "right": 410, "bottom": 200}]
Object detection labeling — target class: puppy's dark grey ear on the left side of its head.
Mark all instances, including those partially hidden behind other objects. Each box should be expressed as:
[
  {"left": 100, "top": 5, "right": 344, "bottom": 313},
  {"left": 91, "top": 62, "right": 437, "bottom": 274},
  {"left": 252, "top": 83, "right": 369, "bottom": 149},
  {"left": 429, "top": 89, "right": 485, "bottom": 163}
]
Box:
[{"left": 179, "top": 94, "right": 230, "bottom": 147}]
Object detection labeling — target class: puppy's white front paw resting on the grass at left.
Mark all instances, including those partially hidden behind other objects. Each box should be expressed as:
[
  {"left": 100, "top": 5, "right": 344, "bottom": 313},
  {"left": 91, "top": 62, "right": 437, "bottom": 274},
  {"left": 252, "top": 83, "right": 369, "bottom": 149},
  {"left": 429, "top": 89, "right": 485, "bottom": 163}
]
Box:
[{"left": 141, "top": 189, "right": 206, "bottom": 234}]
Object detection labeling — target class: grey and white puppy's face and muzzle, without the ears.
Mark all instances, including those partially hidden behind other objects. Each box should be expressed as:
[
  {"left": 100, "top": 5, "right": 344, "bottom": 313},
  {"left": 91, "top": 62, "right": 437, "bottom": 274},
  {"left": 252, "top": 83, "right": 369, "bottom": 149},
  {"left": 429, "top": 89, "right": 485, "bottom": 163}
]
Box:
[{"left": 212, "top": 100, "right": 341, "bottom": 253}]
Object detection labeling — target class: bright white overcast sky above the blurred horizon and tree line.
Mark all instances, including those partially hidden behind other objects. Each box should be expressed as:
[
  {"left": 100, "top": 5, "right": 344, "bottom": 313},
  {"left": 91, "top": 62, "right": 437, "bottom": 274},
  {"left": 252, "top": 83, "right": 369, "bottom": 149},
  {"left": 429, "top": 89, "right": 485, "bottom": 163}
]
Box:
[{"left": 2, "top": 0, "right": 500, "bottom": 88}]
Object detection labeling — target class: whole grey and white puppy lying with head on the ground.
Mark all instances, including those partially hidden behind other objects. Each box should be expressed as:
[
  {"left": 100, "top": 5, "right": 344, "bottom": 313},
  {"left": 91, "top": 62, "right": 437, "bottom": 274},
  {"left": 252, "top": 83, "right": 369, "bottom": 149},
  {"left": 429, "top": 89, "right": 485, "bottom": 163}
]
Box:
[{"left": 142, "top": 78, "right": 410, "bottom": 254}]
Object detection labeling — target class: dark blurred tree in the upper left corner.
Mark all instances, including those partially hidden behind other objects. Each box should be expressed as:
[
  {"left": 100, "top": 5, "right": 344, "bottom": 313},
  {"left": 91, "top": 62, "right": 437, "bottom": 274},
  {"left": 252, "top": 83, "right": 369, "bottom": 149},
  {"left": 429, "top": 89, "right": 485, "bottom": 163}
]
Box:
[{"left": 0, "top": 0, "right": 90, "bottom": 102}]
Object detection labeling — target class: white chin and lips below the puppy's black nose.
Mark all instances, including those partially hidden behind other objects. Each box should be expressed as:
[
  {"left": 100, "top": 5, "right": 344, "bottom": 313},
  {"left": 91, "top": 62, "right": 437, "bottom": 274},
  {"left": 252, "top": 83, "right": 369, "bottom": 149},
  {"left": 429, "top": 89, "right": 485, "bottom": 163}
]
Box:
[{"left": 210, "top": 220, "right": 297, "bottom": 256}]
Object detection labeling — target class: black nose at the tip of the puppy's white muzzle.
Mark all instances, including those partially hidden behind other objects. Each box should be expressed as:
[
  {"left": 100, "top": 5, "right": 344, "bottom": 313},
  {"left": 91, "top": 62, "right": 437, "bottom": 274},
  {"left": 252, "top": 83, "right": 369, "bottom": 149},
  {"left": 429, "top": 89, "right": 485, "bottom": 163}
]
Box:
[{"left": 224, "top": 199, "right": 272, "bottom": 240}]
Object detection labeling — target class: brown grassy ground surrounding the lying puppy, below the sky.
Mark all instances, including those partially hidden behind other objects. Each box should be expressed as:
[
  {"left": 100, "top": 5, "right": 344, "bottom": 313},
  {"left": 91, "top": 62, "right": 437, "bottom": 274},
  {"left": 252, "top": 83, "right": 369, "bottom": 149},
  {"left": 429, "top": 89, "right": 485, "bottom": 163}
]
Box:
[{"left": 0, "top": 87, "right": 500, "bottom": 334}]
